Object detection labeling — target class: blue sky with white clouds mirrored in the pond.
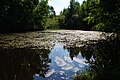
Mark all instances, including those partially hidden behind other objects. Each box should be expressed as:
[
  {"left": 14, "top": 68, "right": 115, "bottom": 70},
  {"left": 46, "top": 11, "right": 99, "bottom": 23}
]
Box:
[{"left": 33, "top": 44, "right": 88, "bottom": 80}]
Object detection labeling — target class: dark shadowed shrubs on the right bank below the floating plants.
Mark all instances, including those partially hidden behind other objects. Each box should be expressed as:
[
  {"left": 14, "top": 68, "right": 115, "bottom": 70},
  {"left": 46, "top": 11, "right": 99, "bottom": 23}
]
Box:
[{"left": 84, "top": 35, "right": 120, "bottom": 80}]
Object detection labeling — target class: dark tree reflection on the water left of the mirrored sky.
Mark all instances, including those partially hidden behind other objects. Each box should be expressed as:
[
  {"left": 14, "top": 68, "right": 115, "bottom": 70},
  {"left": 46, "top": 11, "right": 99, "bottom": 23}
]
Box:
[{"left": 0, "top": 49, "right": 50, "bottom": 80}]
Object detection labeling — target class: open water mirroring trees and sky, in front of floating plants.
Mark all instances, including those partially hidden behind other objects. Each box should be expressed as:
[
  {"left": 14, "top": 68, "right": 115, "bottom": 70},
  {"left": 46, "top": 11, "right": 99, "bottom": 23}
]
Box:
[{"left": 0, "top": 43, "right": 89, "bottom": 80}]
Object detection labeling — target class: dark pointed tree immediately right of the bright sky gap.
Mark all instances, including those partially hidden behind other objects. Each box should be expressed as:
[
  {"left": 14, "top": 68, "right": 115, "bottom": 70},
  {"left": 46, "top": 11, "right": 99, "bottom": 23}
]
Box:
[{"left": 63, "top": 0, "right": 80, "bottom": 29}]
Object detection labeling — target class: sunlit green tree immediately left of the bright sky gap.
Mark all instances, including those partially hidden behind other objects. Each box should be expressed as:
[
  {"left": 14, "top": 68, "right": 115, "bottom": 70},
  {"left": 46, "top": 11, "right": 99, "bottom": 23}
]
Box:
[{"left": 33, "top": 0, "right": 49, "bottom": 30}]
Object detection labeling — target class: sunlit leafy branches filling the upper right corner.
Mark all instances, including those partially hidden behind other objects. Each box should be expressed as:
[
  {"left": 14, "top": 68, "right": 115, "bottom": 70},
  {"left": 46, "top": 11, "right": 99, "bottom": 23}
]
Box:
[{"left": 86, "top": 0, "right": 120, "bottom": 32}]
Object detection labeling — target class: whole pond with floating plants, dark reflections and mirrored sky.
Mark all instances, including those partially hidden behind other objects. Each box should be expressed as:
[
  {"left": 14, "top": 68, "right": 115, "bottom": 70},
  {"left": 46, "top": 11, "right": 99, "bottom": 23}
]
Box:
[{"left": 0, "top": 30, "right": 120, "bottom": 80}]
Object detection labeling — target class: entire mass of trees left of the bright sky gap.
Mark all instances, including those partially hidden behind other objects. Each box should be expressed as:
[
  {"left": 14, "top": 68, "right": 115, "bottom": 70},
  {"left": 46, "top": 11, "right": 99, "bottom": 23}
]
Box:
[{"left": 0, "top": 0, "right": 49, "bottom": 32}]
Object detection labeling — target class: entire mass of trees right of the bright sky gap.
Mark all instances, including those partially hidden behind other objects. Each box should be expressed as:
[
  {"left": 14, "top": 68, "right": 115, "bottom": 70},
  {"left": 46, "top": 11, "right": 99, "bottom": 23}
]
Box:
[{"left": 60, "top": 0, "right": 120, "bottom": 32}]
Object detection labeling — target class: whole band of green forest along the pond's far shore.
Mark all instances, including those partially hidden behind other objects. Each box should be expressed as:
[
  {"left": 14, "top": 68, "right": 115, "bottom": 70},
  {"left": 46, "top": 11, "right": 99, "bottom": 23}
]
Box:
[{"left": 0, "top": 0, "right": 120, "bottom": 32}]
